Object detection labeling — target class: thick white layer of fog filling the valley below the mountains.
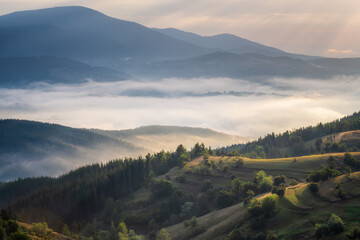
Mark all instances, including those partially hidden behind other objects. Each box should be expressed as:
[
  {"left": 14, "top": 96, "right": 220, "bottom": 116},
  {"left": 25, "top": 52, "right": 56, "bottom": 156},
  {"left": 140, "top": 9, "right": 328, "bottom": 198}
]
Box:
[{"left": 0, "top": 77, "right": 360, "bottom": 137}]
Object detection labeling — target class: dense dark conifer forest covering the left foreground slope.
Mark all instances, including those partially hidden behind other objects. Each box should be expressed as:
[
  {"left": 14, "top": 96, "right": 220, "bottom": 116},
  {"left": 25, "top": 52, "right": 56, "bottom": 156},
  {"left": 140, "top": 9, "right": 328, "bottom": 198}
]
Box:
[{"left": 0, "top": 144, "right": 204, "bottom": 232}]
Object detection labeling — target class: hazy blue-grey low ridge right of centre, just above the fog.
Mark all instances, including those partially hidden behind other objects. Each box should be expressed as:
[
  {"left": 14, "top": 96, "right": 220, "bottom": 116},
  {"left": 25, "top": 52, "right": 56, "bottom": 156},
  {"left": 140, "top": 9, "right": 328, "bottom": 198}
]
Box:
[{"left": 138, "top": 52, "right": 338, "bottom": 79}]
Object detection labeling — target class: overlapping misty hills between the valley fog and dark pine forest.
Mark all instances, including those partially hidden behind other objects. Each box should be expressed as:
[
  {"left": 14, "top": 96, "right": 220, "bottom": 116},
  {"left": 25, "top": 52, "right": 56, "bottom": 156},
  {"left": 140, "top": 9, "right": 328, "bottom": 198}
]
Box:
[{"left": 0, "top": 120, "right": 247, "bottom": 181}]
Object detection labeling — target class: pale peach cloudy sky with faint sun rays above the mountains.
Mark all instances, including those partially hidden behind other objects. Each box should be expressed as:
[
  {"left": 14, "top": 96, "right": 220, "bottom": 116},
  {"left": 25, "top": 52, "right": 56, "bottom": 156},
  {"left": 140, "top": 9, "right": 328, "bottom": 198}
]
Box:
[{"left": 0, "top": 0, "right": 360, "bottom": 57}]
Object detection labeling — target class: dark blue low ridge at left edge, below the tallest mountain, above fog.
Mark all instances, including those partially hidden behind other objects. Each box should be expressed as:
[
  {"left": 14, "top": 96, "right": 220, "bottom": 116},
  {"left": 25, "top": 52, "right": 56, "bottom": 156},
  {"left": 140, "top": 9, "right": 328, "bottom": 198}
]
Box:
[{"left": 0, "top": 56, "right": 129, "bottom": 87}]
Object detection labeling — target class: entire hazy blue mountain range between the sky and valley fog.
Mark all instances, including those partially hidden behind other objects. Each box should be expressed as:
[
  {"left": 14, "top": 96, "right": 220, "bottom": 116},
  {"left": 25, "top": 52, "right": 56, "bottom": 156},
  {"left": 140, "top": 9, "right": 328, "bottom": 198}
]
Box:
[{"left": 0, "top": 6, "right": 360, "bottom": 87}]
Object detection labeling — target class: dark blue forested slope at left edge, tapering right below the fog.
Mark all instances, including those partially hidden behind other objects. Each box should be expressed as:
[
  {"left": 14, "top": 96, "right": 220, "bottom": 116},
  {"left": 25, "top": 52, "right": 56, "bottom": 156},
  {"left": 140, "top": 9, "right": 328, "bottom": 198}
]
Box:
[{"left": 0, "top": 120, "right": 148, "bottom": 180}]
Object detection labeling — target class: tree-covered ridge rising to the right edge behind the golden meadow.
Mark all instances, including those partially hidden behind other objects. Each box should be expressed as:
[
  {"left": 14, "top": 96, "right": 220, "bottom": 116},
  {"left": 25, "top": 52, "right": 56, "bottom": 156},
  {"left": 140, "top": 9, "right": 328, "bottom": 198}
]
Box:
[{"left": 225, "top": 112, "right": 360, "bottom": 158}]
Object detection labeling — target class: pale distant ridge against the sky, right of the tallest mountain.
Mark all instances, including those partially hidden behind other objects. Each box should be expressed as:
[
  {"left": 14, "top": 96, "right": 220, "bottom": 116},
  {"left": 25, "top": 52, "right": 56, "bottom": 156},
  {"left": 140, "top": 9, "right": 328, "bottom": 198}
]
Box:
[{"left": 154, "top": 28, "right": 314, "bottom": 59}]
